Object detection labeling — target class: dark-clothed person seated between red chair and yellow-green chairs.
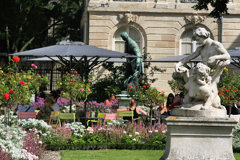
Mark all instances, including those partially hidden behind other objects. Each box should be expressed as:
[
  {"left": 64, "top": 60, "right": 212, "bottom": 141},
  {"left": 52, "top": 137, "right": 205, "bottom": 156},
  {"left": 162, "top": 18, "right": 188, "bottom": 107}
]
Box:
[{"left": 37, "top": 97, "right": 54, "bottom": 119}]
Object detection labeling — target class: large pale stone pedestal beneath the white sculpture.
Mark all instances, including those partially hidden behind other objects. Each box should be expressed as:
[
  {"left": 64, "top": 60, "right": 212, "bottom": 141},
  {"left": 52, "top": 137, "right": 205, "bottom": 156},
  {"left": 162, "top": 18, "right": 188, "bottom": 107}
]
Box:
[{"left": 160, "top": 116, "right": 237, "bottom": 160}]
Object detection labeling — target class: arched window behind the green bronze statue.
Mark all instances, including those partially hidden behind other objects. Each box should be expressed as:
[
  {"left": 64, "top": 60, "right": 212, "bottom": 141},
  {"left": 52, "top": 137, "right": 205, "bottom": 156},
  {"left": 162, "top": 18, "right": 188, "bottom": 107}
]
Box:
[{"left": 113, "top": 26, "right": 142, "bottom": 52}]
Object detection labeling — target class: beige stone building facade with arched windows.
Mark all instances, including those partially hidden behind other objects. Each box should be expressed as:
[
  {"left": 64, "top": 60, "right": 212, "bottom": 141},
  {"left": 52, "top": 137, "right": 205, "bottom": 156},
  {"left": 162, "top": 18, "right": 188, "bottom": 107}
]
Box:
[{"left": 82, "top": 0, "right": 240, "bottom": 92}]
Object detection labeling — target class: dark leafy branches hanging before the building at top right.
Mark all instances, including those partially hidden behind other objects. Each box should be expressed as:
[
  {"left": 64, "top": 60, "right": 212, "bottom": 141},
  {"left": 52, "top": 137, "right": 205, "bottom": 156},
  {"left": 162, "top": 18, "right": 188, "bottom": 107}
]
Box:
[{"left": 193, "top": 0, "right": 229, "bottom": 18}]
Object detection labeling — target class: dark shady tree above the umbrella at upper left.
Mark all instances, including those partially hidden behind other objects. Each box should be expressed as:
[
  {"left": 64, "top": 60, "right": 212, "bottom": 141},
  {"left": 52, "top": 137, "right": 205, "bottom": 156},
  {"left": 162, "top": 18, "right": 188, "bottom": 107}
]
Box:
[{"left": 0, "top": 0, "right": 82, "bottom": 53}]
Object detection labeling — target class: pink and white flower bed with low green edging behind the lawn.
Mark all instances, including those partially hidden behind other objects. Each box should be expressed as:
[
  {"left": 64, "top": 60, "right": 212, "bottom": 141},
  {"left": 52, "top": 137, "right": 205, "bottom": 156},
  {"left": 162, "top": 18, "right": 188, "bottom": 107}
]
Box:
[{"left": 45, "top": 122, "right": 166, "bottom": 150}]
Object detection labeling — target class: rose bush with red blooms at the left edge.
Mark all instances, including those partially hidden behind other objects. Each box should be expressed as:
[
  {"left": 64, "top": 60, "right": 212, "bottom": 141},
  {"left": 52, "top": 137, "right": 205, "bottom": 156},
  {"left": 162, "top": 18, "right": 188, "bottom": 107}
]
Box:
[{"left": 0, "top": 57, "right": 49, "bottom": 106}]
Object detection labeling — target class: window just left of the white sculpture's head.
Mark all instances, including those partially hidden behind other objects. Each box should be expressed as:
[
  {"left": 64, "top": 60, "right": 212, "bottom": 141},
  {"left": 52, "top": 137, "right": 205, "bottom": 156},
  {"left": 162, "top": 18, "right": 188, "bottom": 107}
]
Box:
[{"left": 180, "top": 29, "right": 200, "bottom": 55}]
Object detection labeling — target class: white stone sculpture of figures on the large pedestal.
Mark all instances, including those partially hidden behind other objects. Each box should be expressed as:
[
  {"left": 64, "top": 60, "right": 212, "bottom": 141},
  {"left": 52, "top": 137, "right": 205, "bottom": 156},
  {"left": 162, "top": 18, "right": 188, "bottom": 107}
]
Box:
[{"left": 174, "top": 28, "right": 230, "bottom": 115}]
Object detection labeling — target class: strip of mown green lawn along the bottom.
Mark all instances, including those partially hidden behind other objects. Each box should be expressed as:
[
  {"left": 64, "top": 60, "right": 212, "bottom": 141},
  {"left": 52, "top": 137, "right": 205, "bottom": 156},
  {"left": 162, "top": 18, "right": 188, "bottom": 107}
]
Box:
[{"left": 61, "top": 150, "right": 240, "bottom": 160}]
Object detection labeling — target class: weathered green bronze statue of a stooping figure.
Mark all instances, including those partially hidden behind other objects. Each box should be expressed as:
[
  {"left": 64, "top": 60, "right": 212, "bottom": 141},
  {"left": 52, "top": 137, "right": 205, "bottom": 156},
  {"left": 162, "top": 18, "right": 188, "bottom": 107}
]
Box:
[{"left": 121, "top": 32, "right": 144, "bottom": 87}]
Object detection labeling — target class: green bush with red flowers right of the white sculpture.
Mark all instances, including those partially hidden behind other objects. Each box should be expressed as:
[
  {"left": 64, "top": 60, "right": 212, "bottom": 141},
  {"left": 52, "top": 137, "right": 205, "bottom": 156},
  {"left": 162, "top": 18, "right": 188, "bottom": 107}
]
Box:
[{"left": 218, "top": 68, "right": 240, "bottom": 106}]
